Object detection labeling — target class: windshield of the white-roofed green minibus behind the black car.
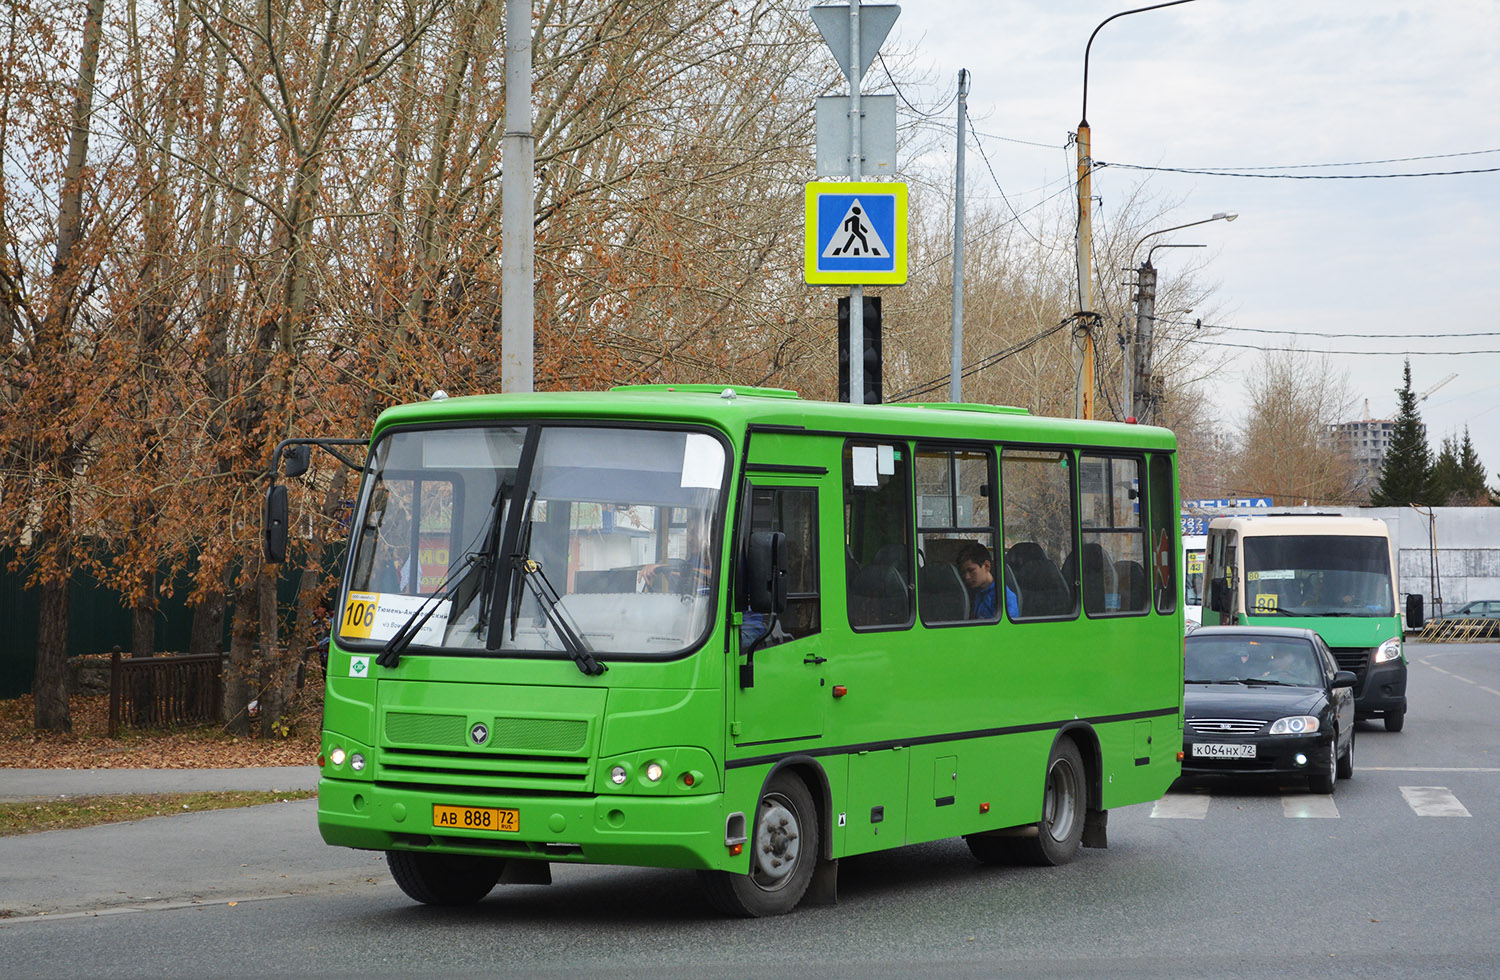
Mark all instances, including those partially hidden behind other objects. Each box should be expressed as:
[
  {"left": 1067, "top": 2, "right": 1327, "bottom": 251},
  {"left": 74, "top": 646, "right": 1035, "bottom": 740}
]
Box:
[{"left": 1242, "top": 534, "right": 1395, "bottom": 617}]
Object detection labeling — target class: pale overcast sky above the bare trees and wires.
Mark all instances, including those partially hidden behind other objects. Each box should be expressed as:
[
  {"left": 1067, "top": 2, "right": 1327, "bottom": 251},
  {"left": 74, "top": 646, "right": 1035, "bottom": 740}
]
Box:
[{"left": 864, "top": 0, "right": 1500, "bottom": 485}]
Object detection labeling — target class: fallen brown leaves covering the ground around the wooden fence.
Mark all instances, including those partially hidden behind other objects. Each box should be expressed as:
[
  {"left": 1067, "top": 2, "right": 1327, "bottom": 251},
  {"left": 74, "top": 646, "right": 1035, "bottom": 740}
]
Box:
[{"left": 0, "top": 695, "right": 320, "bottom": 768}]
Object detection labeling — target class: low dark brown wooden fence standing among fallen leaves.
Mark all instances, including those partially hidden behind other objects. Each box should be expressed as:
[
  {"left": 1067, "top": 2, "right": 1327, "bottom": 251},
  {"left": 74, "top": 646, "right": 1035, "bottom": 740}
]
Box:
[{"left": 110, "top": 647, "right": 224, "bottom": 737}]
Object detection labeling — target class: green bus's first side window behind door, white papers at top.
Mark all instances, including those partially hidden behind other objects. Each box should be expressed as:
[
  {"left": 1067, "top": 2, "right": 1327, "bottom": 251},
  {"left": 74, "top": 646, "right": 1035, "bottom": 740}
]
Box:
[{"left": 843, "top": 441, "right": 915, "bottom": 629}]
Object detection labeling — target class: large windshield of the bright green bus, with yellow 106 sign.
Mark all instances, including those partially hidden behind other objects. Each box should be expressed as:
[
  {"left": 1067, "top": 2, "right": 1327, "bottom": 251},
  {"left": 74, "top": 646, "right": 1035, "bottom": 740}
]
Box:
[{"left": 339, "top": 425, "right": 726, "bottom": 657}]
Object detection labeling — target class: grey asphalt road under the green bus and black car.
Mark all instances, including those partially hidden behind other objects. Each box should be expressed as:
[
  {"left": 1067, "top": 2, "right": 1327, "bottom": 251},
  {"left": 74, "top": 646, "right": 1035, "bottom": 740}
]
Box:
[{"left": 0, "top": 644, "right": 1500, "bottom": 980}]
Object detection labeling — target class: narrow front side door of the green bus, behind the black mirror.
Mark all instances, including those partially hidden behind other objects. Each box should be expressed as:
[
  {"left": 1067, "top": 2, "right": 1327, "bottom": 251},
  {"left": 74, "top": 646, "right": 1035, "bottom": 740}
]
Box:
[{"left": 731, "top": 483, "right": 828, "bottom": 747}]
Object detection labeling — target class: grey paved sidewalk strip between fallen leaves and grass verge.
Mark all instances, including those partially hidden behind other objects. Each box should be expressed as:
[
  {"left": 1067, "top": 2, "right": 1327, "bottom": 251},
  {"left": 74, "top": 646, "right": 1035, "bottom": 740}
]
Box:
[{"left": 0, "top": 765, "right": 318, "bottom": 803}]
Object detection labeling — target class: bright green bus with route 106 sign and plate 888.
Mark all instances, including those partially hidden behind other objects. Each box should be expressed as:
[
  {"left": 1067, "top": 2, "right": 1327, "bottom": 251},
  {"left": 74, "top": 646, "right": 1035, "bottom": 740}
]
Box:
[{"left": 267, "top": 384, "right": 1184, "bottom": 915}]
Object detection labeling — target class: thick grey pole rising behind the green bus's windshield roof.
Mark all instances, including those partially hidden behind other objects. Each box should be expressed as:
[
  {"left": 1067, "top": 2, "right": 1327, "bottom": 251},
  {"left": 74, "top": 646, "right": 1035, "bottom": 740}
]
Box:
[{"left": 500, "top": 0, "right": 536, "bottom": 392}]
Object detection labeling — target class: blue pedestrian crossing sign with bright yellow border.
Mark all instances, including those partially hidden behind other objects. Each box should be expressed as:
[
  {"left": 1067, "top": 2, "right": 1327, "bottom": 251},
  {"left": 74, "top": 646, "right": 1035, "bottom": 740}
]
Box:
[{"left": 803, "top": 180, "right": 906, "bottom": 285}]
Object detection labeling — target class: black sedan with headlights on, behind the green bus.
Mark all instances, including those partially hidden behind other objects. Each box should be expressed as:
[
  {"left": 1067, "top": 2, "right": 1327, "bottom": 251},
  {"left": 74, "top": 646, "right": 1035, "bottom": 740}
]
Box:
[{"left": 1182, "top": 626, "right": 1355, "bottom": 792}]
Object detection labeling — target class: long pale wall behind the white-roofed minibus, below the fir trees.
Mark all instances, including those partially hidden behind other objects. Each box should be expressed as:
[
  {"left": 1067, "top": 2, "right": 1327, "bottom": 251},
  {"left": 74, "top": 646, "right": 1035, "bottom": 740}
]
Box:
[{"left": 1182, "top": 507, "right": 1500, "bottom": 617}]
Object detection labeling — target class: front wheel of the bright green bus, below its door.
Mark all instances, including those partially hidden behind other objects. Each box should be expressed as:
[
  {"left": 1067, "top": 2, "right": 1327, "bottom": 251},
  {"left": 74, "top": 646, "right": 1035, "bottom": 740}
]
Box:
[{"left": 701, "top": 773, "right": 819, "bottom": 917}]
